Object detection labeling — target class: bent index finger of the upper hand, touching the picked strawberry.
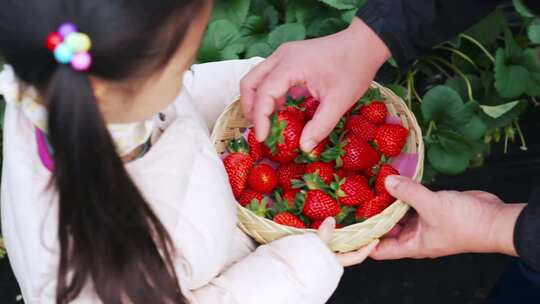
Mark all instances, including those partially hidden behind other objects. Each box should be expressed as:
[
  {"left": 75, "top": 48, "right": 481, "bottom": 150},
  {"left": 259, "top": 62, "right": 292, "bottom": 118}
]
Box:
[{"left": 253, "top": 66, "right": 298, "bottom": 142}]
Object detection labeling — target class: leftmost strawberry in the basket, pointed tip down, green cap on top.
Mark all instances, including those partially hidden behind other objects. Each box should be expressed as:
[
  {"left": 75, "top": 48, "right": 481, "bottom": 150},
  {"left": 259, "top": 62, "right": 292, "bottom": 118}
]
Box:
[{"left": 223, "top": 137, "right": 253, "bottom": 198}]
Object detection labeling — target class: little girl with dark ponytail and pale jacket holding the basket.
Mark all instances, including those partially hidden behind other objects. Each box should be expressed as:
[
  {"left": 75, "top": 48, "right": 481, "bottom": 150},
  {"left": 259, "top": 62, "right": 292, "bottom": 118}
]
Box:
[{"left": 0, "top": 0, "right": 371, "bottom": 304}]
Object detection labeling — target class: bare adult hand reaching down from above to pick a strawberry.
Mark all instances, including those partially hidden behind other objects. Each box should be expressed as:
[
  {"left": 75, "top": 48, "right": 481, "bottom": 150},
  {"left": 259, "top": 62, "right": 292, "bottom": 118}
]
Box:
[{"left": 241, "top": 18, "right": 390, "bottom": 152}]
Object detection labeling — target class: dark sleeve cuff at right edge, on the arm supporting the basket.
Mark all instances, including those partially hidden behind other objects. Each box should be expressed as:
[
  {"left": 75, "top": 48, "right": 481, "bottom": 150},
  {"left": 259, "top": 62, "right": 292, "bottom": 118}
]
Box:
[{"left": 514, "top": 188, "right": 540, "bottom": 272}]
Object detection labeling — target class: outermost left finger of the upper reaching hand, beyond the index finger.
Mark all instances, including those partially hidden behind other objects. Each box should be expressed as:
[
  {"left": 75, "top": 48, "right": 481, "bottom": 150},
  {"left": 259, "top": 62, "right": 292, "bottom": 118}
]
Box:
[{"left": 240, "top": 56, "right": 279, "bottom": 119}]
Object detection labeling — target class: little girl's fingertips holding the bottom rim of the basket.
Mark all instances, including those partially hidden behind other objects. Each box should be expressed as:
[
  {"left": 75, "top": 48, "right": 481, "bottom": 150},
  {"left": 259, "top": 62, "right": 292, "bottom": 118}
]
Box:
[{"left": 317, "top": 217, "right": 379, "bottom": 267}]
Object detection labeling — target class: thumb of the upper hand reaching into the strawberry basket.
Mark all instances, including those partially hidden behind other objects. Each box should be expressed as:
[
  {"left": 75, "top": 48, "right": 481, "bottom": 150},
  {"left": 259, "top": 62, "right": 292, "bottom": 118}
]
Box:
[{"left": 300, "top": 92, "right": 354, "bottom": 152}]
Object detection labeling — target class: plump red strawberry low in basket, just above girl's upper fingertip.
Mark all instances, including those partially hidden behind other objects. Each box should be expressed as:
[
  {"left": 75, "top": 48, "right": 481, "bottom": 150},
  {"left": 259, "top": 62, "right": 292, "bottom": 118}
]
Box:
[{"left": 302, "top": 190, "right": 340, "bottom": 220}]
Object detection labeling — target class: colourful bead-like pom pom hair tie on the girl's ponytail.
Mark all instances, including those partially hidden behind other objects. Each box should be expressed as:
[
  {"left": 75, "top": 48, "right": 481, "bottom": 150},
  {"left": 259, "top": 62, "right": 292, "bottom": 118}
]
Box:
[{"left": 46, "top": 23, "right": 92, "bottom": 72}]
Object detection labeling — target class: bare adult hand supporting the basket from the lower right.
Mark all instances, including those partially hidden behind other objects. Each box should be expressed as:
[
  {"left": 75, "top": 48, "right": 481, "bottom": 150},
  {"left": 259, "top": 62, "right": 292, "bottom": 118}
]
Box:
[{"left": 371, "top": 176, "right": 525, "bottom": 260}]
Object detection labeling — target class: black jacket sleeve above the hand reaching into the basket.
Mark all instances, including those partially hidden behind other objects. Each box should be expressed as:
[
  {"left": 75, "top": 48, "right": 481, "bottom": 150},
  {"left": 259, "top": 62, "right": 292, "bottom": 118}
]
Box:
[{"left": 357, "top": 0, "right": 505, "bottom": 67}]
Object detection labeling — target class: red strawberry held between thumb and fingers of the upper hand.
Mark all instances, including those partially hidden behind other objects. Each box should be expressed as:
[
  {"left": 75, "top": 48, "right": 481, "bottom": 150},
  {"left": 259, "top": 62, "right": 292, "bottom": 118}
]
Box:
[{"left": 262, "top": 110, "right": 304, "bottom": 164}]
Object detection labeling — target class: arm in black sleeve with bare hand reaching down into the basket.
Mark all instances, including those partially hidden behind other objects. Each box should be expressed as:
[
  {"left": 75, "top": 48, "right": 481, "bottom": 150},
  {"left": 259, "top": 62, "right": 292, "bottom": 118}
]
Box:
[{"left": 241, "top": 0, "right": 506, "bottom": 151}]
